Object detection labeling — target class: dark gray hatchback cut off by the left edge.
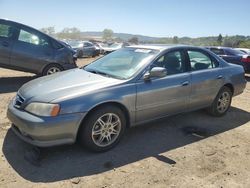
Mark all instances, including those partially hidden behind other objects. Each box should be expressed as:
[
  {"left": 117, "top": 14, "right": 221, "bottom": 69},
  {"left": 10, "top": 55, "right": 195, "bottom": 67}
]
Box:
[{"left": 0, "top": 19, "right": 77, "bottom": 75}]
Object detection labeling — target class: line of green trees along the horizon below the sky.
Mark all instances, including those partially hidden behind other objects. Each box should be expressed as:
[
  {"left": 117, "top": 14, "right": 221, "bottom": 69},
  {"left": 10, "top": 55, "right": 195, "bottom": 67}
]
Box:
[{"left": 40, "top": 27, "right": 250, "bottom": 48}]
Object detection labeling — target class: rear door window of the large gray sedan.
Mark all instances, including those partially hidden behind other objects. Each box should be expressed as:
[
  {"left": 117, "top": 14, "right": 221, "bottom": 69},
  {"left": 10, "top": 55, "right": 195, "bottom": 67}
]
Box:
[{"left": 188, "top": 50, "right": 218, "bottom": 70}]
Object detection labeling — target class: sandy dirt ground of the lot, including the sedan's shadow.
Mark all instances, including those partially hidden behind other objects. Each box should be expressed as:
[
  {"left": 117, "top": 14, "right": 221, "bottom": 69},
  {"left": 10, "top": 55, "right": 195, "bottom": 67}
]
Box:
[{"left": 0, "top": 59, "right": 250, "bottom": 187}]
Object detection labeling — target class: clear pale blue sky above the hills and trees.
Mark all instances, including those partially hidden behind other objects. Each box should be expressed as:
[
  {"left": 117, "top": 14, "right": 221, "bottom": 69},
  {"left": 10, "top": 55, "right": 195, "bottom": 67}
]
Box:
[{"left": 0, "top": 0, "right": 250, "bottom": 37}]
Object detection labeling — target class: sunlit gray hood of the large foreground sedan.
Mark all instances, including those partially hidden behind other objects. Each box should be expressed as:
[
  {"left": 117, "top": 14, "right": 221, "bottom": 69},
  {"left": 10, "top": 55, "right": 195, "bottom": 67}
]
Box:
[{"left": 18, "top": 69, "right": 124, "bottom": 102}]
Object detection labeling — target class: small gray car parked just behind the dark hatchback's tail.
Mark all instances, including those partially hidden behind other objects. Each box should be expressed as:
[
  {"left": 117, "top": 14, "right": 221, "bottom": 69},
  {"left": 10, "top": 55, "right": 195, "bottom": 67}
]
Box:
[{"left": 68, "top": 40, "right": 100, "bottom": 57}]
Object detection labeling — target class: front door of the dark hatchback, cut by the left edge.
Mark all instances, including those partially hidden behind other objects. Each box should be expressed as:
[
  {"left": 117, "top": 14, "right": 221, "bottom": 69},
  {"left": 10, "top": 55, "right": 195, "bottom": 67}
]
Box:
[{"left": 0, "top": 22, "right": 16, "bottom": 67}]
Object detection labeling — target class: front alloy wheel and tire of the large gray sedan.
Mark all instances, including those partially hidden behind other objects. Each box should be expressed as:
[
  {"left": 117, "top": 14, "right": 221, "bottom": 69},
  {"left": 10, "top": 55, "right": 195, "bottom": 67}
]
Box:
[{"left": 78, "top": 106, "right": 126, "bottom": 152}]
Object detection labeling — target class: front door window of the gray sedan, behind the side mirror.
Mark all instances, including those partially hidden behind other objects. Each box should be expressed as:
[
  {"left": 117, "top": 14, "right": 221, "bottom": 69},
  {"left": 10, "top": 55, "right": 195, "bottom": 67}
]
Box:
[{"left": 153, "top": 51, "right": 185, "bottom": 75}]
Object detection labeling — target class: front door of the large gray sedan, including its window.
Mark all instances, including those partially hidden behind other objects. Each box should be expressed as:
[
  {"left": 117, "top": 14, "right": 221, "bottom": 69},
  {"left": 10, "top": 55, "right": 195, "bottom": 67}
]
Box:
[{"left": 136, "top": 50, "right": 191, "bottom": 123}]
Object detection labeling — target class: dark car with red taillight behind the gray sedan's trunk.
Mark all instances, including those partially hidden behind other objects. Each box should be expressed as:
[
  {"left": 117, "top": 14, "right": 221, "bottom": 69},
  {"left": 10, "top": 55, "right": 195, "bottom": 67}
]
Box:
[{"left": 207, "top": 46, "right": 250, "bottom": 72}]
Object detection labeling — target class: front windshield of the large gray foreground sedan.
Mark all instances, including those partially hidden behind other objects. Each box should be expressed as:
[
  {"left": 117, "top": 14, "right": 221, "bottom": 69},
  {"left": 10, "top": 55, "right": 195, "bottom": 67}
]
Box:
[{"left": 84, "top": 48, "right": 158, "bottom": 79}]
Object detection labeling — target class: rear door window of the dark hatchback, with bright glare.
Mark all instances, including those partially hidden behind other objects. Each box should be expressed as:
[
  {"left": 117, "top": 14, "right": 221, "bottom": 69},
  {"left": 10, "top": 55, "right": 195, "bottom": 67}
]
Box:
[{"left": 18, "top": 29, "right": 49, "bottom": 46}]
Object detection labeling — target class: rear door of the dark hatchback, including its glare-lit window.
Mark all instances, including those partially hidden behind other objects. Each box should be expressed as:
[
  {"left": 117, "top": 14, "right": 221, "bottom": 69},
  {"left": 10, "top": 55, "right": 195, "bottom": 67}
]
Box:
[{"left": 10, "top": 28, "right": 54, "bottom": 73}]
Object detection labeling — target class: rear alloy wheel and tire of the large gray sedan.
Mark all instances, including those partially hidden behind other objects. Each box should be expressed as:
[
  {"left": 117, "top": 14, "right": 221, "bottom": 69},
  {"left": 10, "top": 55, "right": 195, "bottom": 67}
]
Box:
[{"left": 208, "top": 86, "right": 233, "bottom": 117}]
